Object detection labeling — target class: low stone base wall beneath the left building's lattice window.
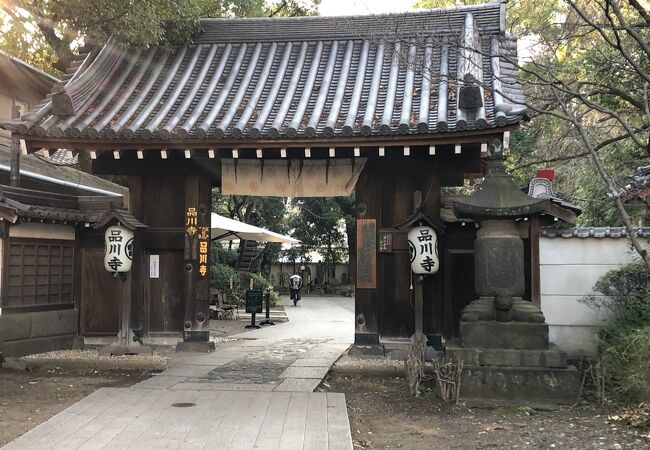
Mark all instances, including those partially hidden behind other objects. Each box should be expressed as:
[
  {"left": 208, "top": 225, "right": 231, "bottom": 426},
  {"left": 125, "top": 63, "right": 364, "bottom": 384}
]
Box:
[{"left": 0, "top": 309, "right": 79, "bottom": 357}]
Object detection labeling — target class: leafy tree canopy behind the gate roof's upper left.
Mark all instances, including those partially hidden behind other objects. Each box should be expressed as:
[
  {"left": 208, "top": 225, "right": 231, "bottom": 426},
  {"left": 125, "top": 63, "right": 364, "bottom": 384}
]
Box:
[{"left": 0, "top": 0, "right": 320, "bottom": 72}]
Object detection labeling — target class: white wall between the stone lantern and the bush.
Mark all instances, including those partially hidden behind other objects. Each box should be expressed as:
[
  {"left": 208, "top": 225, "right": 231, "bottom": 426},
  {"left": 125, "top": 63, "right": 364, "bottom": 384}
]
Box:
[{"left": 539, "top": 236, "right": 638, "bottom": 357}]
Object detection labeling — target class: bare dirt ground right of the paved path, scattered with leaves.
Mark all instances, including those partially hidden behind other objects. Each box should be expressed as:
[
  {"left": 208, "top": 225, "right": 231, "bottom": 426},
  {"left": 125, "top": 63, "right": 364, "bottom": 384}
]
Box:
[{"left": 322, "top": 375, "right": 650, "bottom": 450}]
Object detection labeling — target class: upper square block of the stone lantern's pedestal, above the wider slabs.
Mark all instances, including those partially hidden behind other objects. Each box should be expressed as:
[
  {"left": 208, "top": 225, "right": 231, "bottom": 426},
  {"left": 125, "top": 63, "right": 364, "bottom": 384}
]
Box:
[{"left": 460, "top": 320, "right": 548, "bottom": 350}]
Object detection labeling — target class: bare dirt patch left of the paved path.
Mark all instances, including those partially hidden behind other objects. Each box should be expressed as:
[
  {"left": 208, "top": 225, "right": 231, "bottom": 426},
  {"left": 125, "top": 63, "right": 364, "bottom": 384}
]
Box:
[{"left": 0, "top": 369, "right": 149, "bottom": 447}]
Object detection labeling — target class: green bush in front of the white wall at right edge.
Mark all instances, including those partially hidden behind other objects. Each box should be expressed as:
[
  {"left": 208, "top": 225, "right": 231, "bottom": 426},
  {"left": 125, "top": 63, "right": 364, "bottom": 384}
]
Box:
[{"left": 595, "top": 263, "right": 650, "bottom": 403}]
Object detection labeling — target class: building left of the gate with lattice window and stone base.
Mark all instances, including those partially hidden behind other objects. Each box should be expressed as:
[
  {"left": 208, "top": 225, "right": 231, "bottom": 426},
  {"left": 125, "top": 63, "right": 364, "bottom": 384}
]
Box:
[{"left": 0, "top": 53, "right": 128, "bottom": 356}]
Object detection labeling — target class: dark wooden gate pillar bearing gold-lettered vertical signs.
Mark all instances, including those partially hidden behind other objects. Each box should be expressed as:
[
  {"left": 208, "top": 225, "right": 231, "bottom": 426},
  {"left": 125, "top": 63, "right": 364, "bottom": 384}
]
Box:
[{"left": 183, "top": 175, "right": 211, "bottom": 342}]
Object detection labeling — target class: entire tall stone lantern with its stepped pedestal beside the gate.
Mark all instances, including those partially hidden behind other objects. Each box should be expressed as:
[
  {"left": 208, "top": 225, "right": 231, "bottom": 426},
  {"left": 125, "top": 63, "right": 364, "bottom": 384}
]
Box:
[{"left": 448, "top": 141, "right": 578, "bottom": 402}]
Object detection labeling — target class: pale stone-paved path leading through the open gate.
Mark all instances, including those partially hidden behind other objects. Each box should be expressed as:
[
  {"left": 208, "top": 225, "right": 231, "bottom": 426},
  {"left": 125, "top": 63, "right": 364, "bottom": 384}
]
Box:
[{"left": 4, "top": 297, "right": 354, "bottom": 450}]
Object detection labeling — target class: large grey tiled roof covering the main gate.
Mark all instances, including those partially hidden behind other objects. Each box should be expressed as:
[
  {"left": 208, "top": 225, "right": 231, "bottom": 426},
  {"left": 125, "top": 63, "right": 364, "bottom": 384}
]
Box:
[{"left": 5, "top": 2, "right": 526, "bottom": 141}]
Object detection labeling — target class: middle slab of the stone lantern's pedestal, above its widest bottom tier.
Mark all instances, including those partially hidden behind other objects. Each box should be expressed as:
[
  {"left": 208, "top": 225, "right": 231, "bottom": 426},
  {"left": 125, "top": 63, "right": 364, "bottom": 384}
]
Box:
[{"left": 447, "top": 344, "right": 567, "bottom": 369}]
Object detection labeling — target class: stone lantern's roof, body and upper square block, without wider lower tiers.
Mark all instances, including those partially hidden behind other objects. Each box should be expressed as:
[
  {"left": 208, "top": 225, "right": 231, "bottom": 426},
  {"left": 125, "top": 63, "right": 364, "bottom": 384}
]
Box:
[{"left": 454, "top": 141, "right": 548, "bottom": 348}]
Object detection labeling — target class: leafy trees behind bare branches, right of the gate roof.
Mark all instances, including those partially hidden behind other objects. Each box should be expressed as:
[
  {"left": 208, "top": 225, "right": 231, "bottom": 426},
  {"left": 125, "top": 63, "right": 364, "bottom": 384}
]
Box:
[{"left": 418, "top": 0, "right": 650, "bottom": 270}]
